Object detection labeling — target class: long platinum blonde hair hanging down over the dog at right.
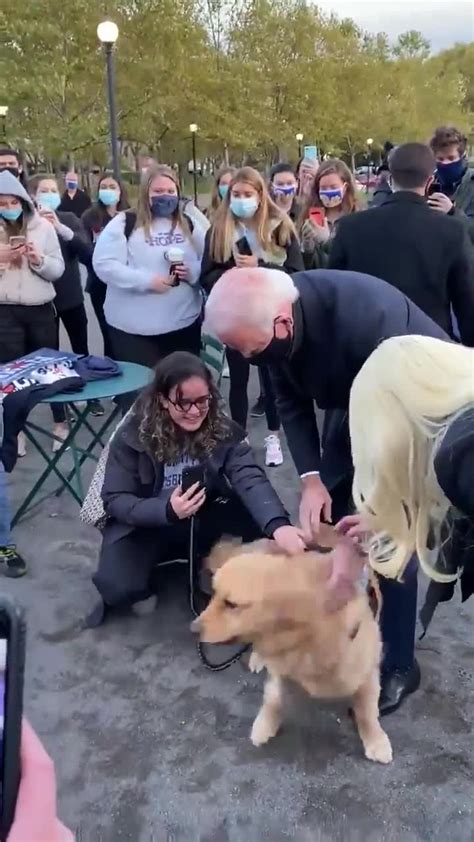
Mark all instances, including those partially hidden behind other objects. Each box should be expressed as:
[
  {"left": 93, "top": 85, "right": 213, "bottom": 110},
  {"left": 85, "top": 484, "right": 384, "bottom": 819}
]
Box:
[{"left": 349, "top": 336, "right": 474, "bottom": 582}]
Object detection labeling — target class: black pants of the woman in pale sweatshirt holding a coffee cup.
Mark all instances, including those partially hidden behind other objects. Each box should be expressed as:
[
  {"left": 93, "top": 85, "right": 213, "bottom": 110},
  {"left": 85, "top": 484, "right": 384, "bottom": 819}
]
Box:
[{"left": 109, "top": 318, "right": 201, "bottom": 413}]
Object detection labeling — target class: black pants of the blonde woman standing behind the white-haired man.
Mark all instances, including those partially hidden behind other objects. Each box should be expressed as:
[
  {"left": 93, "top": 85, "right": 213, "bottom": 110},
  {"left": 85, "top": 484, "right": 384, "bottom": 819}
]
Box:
[{"left": 226, "top": 348, "right": 280, "bottom": 432}]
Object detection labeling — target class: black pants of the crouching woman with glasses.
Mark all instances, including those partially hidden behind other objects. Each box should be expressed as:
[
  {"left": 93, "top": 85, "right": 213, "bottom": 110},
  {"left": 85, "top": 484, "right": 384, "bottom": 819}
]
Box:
[{"left": 92, "top": 497, "right": 262, "bottom": 606}]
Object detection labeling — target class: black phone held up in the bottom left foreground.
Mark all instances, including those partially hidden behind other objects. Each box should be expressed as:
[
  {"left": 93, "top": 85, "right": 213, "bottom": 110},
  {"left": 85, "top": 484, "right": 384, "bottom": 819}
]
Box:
[{"left": 0, "top": 596, "right": 26, "bottom": 842}]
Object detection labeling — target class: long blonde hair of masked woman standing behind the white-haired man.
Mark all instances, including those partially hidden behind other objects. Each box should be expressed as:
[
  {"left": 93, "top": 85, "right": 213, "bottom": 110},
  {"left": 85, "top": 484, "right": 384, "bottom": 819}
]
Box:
[{"left": 210, "top": 167, "right": 296, "bottom": 263}]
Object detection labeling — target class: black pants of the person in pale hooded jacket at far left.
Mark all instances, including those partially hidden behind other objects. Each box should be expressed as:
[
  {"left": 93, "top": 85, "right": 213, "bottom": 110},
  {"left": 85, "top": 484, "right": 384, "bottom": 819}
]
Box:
[{"left": 0, "top": 302, "right": 66, "bottom": 424}]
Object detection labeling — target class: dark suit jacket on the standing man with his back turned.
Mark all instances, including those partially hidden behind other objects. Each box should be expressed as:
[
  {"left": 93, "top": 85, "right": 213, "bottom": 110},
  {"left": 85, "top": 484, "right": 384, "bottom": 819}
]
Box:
[{"left": 329, "top": 191, "right": 474, "bottom": 345}]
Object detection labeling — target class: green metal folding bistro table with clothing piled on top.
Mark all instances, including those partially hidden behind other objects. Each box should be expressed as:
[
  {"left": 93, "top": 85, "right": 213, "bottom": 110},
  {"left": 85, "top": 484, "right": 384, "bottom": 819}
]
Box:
[{"left": 12, "top": 362, "right": 153, "bottom": 526}]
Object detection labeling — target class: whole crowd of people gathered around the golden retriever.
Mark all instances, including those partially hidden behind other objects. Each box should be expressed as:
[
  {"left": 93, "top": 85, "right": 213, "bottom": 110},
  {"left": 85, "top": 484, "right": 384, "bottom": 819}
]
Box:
[{"left": 0, "top": 126, "right": 474, "bottom": 832}]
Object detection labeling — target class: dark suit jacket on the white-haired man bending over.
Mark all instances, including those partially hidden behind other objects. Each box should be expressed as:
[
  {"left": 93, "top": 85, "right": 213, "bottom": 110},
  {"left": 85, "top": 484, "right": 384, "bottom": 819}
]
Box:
[{"left": 271, "top": 270, "right": 449, "bottom": 489}]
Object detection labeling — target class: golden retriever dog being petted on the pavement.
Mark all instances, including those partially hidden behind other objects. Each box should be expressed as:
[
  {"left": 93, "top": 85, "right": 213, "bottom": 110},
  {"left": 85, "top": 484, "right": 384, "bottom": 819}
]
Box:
[{"left": 192, "top": 527, "right": 392, "bottom": 763}]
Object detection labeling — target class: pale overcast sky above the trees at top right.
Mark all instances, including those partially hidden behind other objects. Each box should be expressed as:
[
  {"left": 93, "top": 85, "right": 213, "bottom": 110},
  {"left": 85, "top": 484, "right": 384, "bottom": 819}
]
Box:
[{"left": 315, "top": 0, "right": 474, "bottom": 52}]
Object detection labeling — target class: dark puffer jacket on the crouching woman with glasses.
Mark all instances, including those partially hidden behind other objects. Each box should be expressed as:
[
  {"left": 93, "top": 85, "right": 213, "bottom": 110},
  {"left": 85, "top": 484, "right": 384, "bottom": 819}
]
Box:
[{"left": 102, "top": 415, "right": 290, "bottom": 541}]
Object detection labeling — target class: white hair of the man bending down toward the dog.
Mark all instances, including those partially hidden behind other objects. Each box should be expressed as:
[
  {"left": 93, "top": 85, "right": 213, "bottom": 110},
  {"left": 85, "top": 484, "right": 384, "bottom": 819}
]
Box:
[{"left": 204, "top": 268, "right": 298, "bottom": 337}]
